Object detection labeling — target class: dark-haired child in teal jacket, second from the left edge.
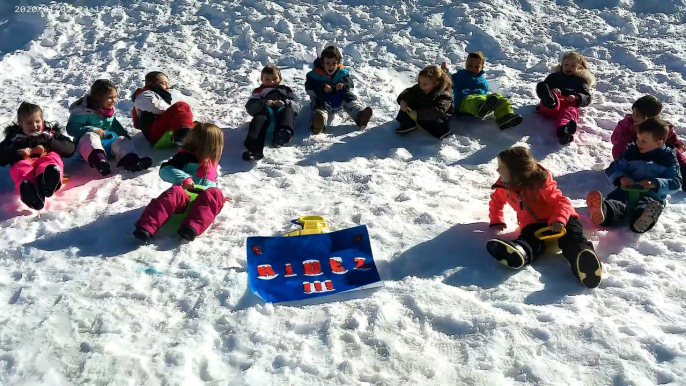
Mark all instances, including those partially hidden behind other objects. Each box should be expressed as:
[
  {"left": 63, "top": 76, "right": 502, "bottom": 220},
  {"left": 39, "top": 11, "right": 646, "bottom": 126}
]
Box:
[{"left": 67, "top": 79, "right": 152, "bottom": 176}]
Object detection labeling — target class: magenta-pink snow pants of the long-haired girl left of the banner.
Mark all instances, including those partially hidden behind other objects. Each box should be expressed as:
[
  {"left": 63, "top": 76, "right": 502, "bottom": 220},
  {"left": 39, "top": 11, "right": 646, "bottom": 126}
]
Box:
[{"left": 136, "top": 185, "right": 224, "bottom": 236}]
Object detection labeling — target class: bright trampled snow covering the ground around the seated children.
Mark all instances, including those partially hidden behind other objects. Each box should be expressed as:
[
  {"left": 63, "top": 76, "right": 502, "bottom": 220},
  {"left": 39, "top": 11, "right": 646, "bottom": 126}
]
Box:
[{"left": 0, "top": 0, "right": 686, "bottom": 385}]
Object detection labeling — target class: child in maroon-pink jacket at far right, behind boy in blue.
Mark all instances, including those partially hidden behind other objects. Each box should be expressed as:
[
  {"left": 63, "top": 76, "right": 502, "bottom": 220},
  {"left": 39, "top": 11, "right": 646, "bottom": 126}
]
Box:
[{"left": 612, "top": 95, "right": 686, "bottom": 190}]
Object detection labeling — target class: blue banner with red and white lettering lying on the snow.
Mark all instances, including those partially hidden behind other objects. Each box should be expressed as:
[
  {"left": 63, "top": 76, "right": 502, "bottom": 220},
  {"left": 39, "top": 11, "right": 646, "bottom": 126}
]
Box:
[{"left": 247, "top": 225, "right": 382, "bottom": 303}]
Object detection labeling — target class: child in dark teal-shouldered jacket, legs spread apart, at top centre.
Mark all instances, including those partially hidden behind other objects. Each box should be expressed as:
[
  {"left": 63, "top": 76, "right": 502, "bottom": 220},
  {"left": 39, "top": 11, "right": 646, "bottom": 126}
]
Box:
[{"left": 305, "top": 46, "right": 373, "bottom": 134}]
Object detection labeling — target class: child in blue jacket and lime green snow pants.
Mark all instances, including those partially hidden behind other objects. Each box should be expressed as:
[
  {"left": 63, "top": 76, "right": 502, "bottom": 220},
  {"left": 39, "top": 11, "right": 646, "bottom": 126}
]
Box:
[{"left": 441, "top": 51, "right": 522, "bottom": 130}]
